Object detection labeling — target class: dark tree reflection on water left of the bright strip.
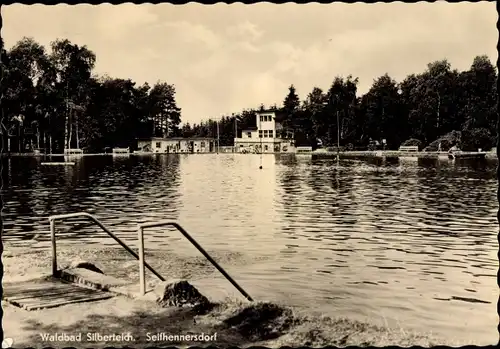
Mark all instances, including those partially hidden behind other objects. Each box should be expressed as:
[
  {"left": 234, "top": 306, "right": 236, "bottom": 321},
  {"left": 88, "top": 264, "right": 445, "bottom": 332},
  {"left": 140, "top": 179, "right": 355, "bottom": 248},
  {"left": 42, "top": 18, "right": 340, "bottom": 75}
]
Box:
[{"left": 2, "top": 155, "right": 180, "bottom": 240}]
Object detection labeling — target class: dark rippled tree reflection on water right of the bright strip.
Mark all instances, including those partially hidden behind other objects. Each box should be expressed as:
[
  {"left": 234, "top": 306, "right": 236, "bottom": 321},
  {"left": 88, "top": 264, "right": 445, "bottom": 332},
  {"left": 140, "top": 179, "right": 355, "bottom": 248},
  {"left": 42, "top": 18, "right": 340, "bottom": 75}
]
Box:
[{"left": 277, "top": 157, "right": 496, "bottom": 256}]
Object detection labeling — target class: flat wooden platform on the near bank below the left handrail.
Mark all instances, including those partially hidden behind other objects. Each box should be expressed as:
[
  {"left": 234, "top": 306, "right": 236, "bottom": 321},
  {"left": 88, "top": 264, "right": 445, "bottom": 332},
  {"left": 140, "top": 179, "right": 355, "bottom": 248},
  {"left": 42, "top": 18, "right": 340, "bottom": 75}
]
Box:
[{"left": 3, "top": 276, "right": 116, "bottom": 310}]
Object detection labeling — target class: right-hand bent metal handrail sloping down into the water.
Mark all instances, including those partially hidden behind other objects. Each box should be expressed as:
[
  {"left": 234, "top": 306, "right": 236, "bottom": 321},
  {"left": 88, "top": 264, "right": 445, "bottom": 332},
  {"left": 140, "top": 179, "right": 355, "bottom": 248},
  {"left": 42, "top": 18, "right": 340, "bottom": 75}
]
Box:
[{"left": 138, "top": 221, "right": 253, "bottom": 302}]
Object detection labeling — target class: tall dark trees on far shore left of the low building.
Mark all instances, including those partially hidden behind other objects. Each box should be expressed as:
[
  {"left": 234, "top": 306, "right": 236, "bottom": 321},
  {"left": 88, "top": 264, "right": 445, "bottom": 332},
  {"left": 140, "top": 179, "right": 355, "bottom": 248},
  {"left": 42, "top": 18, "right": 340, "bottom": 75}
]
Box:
[{"left": 0, "top": 38, "right": 181, "bottom": 153}]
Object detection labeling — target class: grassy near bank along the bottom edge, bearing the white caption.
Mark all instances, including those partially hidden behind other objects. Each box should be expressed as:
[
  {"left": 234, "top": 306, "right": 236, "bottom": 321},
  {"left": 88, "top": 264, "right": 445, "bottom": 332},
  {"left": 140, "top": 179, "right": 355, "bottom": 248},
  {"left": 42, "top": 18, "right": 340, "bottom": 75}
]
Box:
[{"left": 3, "top": 297, "right": 459, "bottom": 348}]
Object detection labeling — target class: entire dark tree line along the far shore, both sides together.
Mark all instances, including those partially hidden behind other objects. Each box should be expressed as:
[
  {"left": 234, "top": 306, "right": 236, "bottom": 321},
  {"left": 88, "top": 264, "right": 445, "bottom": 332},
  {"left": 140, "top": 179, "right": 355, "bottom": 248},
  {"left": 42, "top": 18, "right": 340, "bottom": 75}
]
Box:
[{"left": 0, "top": 38, "right": 497, "bottom": 153}]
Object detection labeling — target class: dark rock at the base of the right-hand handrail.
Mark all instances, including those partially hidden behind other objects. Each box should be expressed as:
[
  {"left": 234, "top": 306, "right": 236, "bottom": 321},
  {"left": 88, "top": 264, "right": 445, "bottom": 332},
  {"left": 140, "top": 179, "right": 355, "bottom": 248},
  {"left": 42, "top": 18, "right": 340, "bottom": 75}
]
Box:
[{"left": 155, "top": 280, "right": 210, "bottom": 307}]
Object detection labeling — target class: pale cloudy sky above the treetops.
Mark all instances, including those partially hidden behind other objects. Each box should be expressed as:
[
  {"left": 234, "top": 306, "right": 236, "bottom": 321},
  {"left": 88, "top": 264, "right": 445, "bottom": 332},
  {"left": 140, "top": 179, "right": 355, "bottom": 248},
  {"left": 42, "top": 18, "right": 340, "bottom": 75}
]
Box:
[{"left": 2, "top": 2, "right": 498, "bottom": 123}]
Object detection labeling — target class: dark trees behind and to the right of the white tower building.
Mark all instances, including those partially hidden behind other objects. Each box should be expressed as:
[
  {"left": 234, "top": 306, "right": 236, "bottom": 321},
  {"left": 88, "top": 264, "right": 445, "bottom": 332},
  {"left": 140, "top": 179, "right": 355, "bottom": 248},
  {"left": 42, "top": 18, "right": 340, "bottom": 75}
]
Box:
[{"left": 187, "top": 56, "right": 497, "bottom": 150}]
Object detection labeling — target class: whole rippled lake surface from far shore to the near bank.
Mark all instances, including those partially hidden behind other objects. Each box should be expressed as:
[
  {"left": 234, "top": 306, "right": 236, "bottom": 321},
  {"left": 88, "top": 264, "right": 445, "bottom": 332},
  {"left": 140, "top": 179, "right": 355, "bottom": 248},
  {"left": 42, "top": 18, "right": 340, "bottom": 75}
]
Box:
[{"left": 2, "top": 154, "right": 498, "bottom": 344}]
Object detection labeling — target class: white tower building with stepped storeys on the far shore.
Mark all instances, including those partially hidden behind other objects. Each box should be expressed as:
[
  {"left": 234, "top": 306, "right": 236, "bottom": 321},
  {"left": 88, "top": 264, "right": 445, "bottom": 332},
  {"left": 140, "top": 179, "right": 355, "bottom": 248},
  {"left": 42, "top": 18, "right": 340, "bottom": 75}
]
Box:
[{"left": 234, "top": 110, "right": 295, "bottom": 153}]
